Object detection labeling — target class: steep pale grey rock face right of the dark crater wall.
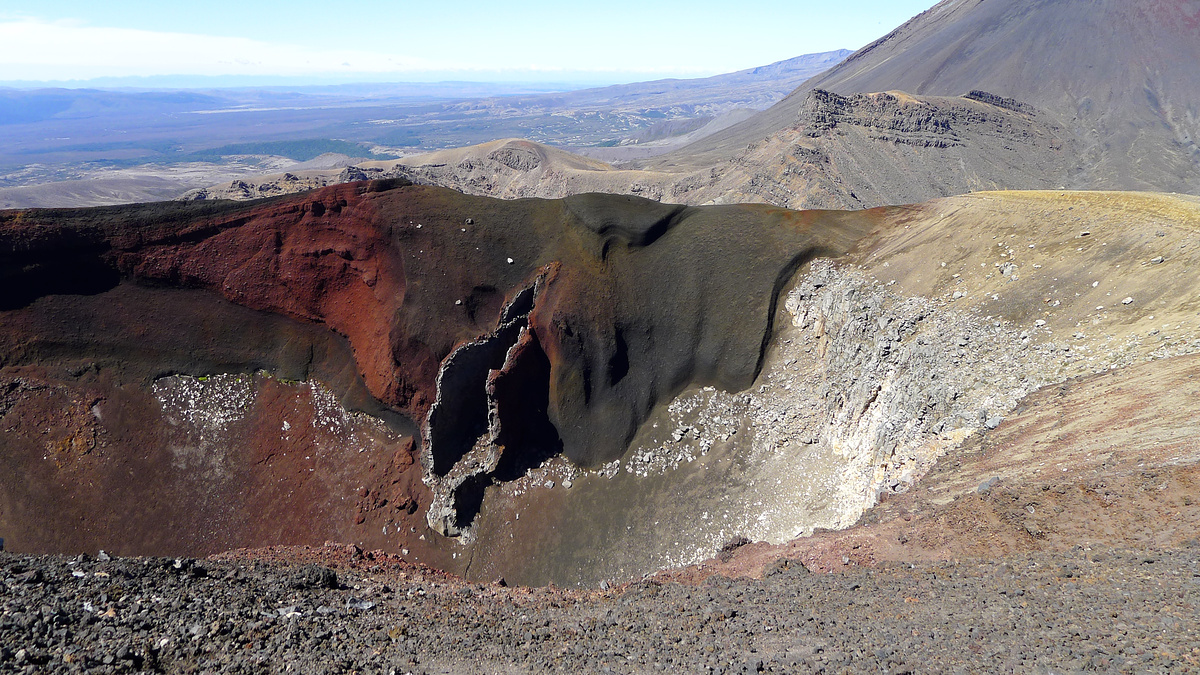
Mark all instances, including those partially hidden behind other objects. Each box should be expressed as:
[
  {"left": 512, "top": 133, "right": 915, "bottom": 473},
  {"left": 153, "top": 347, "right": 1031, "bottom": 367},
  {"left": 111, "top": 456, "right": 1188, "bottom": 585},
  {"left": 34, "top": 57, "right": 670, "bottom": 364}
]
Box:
[{"left": 786, "top": 261, "right": 1057, "bottom": 506}]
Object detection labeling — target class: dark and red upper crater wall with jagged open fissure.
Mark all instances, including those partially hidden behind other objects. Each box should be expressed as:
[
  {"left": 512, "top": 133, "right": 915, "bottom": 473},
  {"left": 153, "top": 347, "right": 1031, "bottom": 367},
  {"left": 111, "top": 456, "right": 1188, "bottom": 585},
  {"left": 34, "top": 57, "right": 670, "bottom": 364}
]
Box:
[{"left": 0, "top": 180, "right": 872, "bottom": 552}]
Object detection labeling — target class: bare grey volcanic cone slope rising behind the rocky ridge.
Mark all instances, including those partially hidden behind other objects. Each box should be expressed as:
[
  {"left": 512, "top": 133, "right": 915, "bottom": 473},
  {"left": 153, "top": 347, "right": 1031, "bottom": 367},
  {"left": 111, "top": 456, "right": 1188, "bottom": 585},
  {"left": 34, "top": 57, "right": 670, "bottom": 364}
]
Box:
[{"left": 644, "top": 0, "right": 1200, "bottom": 191}]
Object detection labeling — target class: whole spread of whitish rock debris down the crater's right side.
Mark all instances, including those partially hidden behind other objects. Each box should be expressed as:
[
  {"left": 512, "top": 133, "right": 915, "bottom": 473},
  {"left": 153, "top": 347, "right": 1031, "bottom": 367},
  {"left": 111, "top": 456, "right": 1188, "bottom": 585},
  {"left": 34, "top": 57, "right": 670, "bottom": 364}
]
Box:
[{"left": 595, "top": 255, "right": 1200, "bottom": 565}]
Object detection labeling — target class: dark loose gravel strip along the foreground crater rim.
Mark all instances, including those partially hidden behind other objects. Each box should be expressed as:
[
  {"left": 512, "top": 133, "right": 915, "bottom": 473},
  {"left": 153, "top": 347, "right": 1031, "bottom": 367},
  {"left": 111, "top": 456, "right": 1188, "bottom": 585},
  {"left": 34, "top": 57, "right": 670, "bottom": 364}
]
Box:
[{"left": 0, "top": 544, "right": 1200, "bottom": 674}]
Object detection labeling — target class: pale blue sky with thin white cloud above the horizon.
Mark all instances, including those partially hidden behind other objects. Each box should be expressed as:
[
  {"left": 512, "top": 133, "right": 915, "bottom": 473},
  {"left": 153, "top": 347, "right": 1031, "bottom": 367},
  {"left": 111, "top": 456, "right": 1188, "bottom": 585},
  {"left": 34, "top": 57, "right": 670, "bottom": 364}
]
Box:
[{"left": 0, "top": 0, "right": 935, "bottom": 85}]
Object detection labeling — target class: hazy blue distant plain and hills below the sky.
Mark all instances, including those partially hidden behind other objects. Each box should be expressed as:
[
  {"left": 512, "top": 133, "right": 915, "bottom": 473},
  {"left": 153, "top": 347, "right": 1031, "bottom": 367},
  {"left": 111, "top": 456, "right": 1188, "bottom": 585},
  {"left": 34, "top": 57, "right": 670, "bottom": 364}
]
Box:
[{"left": 0, "top": 50, "right": 850, "bottom": 208}]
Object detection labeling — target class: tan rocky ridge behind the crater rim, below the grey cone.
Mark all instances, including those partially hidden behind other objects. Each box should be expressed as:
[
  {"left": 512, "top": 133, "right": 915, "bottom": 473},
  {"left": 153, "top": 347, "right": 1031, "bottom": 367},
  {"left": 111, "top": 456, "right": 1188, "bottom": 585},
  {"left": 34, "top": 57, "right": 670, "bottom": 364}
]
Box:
[{"left": 184, "top": 90, "right": 1075, "bottom": 209}]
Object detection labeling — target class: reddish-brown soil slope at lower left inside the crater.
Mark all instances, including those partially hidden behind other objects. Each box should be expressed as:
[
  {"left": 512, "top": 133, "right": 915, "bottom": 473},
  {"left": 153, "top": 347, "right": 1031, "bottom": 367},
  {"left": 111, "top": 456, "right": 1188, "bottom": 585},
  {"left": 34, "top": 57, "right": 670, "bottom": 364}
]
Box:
[{"left": 0, "top": 362, "right": 446, "bottom": 560}]
